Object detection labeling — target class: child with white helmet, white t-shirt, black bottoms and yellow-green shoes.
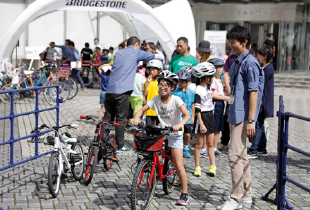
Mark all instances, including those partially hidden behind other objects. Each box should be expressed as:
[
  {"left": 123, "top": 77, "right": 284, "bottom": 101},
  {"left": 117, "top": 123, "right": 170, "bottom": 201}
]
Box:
[{"left": 192, "top": 62, "right": 216, "bottom": 177}]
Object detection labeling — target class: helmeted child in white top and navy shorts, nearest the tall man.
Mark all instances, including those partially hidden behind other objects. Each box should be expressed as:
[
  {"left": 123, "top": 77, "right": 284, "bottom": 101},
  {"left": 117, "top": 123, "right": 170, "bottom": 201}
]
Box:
[{"left": 208, "top": 58, "right": 229, "bottom": 157}]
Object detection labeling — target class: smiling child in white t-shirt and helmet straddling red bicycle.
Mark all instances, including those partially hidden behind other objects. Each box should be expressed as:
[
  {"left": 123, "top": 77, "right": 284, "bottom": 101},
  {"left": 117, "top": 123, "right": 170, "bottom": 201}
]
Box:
[{"left": 132, "top": 70, "right": 190, "bottom": 205}]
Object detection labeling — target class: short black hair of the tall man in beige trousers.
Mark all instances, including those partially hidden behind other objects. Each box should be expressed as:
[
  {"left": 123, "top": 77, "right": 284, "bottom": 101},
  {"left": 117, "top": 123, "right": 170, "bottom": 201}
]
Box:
[{"left": 226, "top": 25, "right": 251, "bottom": 48}]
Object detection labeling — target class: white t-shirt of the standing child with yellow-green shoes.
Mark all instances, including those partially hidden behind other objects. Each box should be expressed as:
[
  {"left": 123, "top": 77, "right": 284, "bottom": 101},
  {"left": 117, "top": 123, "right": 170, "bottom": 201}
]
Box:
[{"left": 194, "top": 85, "right": 213, "bottom": 112}]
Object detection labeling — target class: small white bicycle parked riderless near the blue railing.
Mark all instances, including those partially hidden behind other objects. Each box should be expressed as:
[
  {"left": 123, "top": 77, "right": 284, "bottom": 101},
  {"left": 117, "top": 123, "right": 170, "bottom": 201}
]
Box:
[{"left": 46, "top": 124, "right": 84, "bottom": 198}]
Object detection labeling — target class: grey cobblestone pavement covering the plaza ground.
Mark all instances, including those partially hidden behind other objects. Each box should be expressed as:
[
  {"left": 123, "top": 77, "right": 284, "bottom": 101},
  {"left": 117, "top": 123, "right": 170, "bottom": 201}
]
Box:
[{"left": 0, "top": 88, "right": 310, "bottom": 210}]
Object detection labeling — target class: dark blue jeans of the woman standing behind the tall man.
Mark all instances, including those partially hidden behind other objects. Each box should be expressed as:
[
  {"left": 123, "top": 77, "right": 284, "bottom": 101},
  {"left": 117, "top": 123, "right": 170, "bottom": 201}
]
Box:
[{"left": 250, "top": 117, "right": 267, "bottom": 153}]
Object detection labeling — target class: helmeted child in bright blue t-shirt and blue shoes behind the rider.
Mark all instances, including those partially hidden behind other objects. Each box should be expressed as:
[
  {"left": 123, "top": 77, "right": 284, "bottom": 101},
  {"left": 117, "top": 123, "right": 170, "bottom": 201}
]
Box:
[{"left": 173, "top": 66, "right": 195, "bottom": 158}]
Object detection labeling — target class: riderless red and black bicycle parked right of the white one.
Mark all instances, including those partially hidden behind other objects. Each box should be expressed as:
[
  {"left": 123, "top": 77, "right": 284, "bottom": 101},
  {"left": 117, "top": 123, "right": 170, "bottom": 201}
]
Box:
[{"left": 80, "top": 115, "right": 122, "bottom": 185}]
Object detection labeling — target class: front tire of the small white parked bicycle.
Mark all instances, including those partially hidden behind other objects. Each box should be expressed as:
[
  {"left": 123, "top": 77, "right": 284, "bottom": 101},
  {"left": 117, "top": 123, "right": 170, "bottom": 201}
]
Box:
[{"left": 48, "top": 152, "right": 62, "bottom": 198}]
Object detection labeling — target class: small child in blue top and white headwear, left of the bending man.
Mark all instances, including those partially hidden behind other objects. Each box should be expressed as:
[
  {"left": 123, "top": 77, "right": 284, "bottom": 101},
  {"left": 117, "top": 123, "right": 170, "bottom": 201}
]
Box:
[{"left": 98, "top": 64, "right": 112, "bottom": 120}]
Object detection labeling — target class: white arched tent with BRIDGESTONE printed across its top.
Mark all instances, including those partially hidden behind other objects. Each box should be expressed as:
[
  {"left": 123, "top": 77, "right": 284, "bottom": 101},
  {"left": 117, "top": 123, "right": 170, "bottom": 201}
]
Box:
[{"left": 0, "top": 0, "right": 196, "bottom": 69}]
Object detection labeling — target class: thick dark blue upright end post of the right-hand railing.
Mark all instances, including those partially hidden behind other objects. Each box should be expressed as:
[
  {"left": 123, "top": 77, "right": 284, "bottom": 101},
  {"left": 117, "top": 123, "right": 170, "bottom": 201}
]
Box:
[{"left": 276, "top": 95, "right": 285, "bottom": 210}]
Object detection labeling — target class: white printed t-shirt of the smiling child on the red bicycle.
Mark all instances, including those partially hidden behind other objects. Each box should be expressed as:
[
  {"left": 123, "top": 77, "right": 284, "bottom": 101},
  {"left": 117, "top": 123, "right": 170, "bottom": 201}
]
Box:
[{"left": 147, "top": 95, "right": 184, "bottom": 135}]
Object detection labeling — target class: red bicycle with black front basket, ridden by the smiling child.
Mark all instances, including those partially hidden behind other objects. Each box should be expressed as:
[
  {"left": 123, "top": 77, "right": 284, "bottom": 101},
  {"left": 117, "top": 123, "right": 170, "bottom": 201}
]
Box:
[{"left": 130, "top": 123, "right": 178, "bottom": 210}]
